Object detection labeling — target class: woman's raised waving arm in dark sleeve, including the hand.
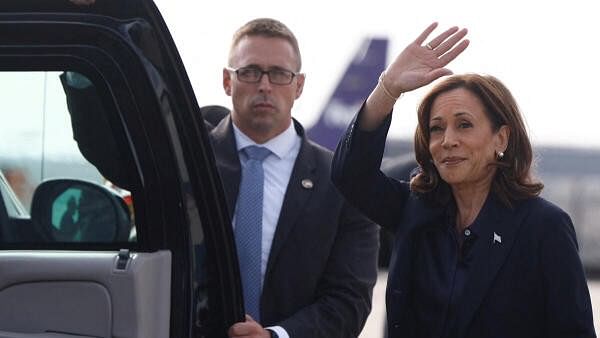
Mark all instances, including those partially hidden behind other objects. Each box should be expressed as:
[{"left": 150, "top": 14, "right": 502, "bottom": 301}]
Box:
[{"left": 332, "top": 23, "right": 469, "bottom": 228}]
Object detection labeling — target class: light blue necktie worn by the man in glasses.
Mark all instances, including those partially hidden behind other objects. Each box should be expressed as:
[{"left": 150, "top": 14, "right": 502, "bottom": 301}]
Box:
[{"left": 234, "top": 146, "right": 271, "bottom": 323}]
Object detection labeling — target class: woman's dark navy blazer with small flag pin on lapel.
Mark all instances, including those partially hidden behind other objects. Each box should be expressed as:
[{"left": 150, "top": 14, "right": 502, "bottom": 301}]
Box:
[{"left": 332, "top": 112, "right": 596, "bottom": 338}]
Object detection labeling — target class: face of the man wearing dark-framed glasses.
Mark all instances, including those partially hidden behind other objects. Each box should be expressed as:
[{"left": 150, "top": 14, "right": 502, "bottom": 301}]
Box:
[{"left": 223, "top": 36, "right": 304, "bottom": 143}]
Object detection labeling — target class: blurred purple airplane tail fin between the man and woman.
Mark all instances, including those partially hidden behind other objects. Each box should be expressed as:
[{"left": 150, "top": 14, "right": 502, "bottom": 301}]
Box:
[{"left": 307, "top": 38, "right": 388, "bottom": 150}]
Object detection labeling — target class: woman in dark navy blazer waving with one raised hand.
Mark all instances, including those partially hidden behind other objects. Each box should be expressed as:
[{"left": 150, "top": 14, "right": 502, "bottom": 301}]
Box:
[{"left": 332, "top": 24, "right": 595, "bottom": 338}]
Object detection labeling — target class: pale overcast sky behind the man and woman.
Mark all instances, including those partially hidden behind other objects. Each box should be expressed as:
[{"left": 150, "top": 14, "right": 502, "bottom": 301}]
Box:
[{"left": 155, "top": 0, "right": 600, "bottom": 148}]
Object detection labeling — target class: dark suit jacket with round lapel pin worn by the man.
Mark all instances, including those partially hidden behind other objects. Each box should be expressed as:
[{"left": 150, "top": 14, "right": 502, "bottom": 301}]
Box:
[{"left": 211, "top": 116, "right": 379, "bottom": 338}]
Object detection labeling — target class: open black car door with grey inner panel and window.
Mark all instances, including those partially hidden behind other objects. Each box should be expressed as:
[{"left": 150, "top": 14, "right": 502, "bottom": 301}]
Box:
[{"left": 0, "top": 0, "right": 244, "bottom": 338}]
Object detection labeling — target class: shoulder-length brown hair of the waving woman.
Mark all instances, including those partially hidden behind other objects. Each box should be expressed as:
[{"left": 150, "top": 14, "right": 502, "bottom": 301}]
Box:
[{"left": 410, "top": 74, "right": 544, "bottom": 206}]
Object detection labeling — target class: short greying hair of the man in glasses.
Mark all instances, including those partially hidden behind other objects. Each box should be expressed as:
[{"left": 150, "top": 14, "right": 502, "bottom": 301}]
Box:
[{"left": 229, "top": 18, "right": 302, "bottom": 71}]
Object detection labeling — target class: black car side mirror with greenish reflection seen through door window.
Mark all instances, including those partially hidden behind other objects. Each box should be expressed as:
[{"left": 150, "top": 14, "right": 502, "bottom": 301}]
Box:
[{"left": 31, "top": 179, "right": 132, "bottom": 243}]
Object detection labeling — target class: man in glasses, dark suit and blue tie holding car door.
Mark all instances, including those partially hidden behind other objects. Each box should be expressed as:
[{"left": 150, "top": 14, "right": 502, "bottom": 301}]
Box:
[{"left": 211, "top": 19, "right": 378, "bottom": 338}]
